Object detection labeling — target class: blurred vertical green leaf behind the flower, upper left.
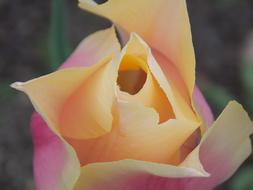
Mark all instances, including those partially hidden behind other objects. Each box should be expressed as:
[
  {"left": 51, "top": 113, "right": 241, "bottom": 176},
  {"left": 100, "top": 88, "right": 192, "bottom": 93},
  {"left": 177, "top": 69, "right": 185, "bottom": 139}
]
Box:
[{"left": 49, "top": 0, "right": 71, "bottom": 70}]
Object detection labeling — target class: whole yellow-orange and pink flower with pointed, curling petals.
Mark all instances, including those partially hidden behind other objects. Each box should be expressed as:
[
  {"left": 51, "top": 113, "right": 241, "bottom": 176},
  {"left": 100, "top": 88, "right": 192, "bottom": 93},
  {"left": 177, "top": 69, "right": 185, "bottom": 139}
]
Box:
[{"left": 12, "top": 0, "right": 253, "bottom": 190}]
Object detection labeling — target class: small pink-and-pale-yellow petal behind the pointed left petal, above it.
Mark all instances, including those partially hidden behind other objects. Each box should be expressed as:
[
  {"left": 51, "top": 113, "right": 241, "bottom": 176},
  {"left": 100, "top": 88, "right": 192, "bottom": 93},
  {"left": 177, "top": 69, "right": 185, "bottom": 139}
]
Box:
[{"left": 60, "top": 26, "right": 120, "bottom": 69}]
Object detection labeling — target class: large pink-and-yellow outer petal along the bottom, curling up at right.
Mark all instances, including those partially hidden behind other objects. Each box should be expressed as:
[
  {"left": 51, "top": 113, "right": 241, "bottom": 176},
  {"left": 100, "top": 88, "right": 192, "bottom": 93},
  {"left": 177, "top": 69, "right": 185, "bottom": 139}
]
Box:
[{"left": 75, "top": 102, "right": 253, "bottom": 190}]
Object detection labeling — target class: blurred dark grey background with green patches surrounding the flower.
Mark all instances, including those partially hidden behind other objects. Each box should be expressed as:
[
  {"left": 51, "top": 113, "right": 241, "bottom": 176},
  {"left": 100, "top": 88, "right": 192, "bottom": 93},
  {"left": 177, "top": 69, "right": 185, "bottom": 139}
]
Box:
[{"left": 0, "top": 0, "right": 253, "bottom": 190}]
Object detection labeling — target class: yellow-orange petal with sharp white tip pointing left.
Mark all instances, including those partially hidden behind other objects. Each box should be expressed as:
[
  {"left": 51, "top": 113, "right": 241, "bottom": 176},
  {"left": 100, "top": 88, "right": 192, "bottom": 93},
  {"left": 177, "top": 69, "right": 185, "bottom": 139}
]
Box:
[{"left": 12, "top": 60, "right": 117, "bottom": 139}]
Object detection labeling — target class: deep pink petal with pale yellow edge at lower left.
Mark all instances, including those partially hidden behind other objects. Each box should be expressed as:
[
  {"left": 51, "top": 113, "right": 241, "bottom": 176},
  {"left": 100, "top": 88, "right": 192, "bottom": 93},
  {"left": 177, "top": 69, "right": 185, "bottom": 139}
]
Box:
[{"left": 31, "top": 113, "right": 80, "bottom": 190}]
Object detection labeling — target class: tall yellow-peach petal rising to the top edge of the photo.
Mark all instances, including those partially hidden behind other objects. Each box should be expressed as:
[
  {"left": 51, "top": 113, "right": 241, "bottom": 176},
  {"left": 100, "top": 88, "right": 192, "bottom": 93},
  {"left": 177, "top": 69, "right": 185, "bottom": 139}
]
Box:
[{"left": 79, "top": 0, "right": 195, "bottom": 94}]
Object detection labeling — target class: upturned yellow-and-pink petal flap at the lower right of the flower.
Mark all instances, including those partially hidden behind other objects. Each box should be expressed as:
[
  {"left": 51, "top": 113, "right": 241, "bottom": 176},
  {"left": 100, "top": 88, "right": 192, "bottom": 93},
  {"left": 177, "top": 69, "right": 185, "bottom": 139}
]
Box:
[{"left": 187, "top": 101, "right": 253, "bottom": 190}]
